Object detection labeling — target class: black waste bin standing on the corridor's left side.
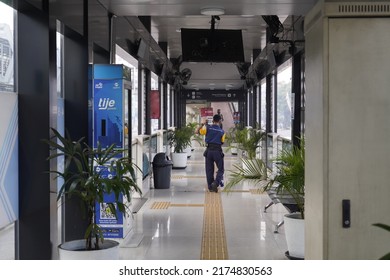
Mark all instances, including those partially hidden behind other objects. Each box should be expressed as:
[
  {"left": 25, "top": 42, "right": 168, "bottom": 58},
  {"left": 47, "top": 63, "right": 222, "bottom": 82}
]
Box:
[{"left": 153, "top": 153, "right": 173, "bottom": 189}]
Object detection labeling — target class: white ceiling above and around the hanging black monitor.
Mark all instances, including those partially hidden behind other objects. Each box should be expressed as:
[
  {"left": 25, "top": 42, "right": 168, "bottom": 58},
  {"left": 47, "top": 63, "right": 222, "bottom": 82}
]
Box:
[{"left": 99, "top": 0, "right": 318, "bottom": 89}]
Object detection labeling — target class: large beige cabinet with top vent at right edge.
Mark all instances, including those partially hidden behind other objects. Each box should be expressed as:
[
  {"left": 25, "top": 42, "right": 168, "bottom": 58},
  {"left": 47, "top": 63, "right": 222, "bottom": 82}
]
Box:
[{"left": 305, "top": 1, "right": 390, "bottom": 259}]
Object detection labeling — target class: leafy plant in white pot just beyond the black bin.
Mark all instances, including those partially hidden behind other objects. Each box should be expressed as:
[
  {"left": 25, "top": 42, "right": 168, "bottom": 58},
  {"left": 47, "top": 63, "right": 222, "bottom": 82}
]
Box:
[{"left": 168, "top": 126, "right": 194, "bottom": 169}]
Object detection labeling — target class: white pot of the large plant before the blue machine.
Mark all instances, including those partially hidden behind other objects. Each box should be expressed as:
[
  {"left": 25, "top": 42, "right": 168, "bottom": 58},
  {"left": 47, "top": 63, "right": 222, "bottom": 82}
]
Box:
[{"left": 58, "top": 239, "right": 119, "bottom": 260}]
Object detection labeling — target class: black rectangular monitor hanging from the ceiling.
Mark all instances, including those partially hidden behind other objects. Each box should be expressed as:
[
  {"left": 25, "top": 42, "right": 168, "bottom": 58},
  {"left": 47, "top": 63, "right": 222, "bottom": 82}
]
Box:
[{"left": 181, "top": 28, "right": 245, "bottom": 63}]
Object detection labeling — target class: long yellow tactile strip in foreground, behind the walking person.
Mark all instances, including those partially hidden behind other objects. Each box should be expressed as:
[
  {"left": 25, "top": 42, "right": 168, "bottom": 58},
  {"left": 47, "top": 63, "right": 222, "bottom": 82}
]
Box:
[{"left": 200, "top": 192, "right": 228, "bottom": 260}]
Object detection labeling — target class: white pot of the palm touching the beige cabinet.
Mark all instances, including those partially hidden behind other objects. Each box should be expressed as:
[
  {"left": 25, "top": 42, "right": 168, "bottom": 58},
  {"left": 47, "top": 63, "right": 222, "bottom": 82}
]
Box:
[{"left": 284, "top": 213, "right": 305, "bottom": 259}]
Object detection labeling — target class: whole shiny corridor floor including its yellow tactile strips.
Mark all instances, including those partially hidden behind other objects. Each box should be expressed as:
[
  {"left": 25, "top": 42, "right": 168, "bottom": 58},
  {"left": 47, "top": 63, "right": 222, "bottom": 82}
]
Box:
[{"left": 120, "top": 147, "right": 287, "bottom": 260}]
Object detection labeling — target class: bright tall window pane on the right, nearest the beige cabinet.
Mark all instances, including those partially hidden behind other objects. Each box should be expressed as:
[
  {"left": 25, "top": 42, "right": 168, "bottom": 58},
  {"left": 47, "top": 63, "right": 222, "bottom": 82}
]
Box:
[{"left": 276, "top": 60, "right": 292, "bottom": 139}]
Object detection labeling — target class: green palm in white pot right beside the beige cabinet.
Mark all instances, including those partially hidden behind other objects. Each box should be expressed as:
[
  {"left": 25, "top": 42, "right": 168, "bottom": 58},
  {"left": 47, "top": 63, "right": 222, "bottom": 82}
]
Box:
[{"left": 265, "top": 138, "right": 305, "bottom": 259}]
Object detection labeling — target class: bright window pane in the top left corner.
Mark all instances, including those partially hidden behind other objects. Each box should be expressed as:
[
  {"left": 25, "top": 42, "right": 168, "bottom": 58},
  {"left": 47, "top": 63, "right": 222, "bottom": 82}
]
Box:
[{"left": 0, "top": 2, "right": 16, "bottom": 92}]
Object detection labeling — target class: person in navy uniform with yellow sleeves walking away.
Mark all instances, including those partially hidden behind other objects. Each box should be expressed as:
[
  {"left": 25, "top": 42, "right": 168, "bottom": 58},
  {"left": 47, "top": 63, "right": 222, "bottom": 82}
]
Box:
[{"left": 199, "top": 114, "right": 225, "bottom": 193}]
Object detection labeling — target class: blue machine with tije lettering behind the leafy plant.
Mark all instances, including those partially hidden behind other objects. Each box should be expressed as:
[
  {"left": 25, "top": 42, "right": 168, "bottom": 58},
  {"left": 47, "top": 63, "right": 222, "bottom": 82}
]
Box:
[{"left": 91, "top": 64, "right": 131, "bottom": 238}]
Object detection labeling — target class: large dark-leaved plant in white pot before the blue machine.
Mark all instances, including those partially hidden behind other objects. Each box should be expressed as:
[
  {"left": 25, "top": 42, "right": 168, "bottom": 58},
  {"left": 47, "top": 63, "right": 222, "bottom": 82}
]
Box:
[{"left": 43, "top": 128, "right": 141, "bottom": 259}]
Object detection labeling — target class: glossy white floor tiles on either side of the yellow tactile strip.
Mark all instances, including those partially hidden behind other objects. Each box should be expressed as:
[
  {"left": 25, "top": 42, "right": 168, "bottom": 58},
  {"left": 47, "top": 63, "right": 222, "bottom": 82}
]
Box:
[{"left": 0, "top": 148, "right": 287, "bottom": 260}]
